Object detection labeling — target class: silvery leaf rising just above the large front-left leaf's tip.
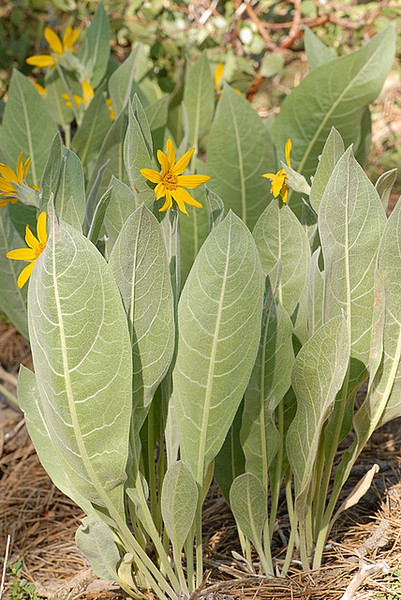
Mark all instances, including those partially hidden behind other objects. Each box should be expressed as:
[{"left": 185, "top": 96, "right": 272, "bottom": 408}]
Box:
[{"left": 54, "top": 147, "right": 86, "bottom": 230}]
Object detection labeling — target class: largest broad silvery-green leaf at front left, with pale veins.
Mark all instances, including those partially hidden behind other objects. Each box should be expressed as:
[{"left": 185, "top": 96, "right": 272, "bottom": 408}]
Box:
[{"left": 28, "top": 215, "right": 132, "bottom": 506}]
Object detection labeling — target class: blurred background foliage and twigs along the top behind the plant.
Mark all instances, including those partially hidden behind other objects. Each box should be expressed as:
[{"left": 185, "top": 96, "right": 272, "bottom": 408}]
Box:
[{"left": 0, "top": 0, "right": 401, "bottom": 185}]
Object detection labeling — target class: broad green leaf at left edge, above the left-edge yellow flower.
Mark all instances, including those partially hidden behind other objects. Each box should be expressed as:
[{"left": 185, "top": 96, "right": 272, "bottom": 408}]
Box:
[{"left": 0, "top": 70, "right": 57, "bottom": 185}]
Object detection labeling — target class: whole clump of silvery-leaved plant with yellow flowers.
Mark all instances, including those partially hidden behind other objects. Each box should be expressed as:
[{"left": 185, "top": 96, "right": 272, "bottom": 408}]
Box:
[{"left": 0, "top": 7, "right": 401, "bottom": 599}]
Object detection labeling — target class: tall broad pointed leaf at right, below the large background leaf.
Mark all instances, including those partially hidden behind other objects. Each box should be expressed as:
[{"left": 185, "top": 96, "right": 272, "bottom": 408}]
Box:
[{"left": 319, "top": 148, "right": 386, "bottom": 381}]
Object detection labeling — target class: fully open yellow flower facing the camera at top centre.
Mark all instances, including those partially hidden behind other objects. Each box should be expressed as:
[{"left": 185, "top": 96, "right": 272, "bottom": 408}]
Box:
[{"left": 141, "top": 138, "right": 210, "bottom": 215}]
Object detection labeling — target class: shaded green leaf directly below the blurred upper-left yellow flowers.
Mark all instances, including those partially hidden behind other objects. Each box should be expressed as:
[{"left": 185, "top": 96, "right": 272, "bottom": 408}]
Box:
[{"left": 71, "top": 86, "right": 112, "bottom": 165}]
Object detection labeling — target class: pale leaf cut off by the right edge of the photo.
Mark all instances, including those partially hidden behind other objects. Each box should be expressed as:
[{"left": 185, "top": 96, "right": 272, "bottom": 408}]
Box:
[{"left": 354, "top": 202, "right": 401, "bottom": 441}]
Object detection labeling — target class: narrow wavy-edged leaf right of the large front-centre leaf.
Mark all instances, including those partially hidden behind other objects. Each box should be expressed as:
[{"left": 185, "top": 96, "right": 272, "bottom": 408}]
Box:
[{"left": 241, "top": 298, "right": 294, "bottom": 491}]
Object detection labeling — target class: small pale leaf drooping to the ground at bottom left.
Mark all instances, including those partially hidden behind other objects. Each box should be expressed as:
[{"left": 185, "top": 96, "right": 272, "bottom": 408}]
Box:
[{"left": 75, "top": 517, "right": 121, "bottom": 581}]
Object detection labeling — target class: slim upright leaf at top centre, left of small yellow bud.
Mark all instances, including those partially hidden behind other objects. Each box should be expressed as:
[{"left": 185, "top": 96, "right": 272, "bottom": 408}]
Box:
[{"left": 184, "top": 51, "right": 214, "bottom": 148}]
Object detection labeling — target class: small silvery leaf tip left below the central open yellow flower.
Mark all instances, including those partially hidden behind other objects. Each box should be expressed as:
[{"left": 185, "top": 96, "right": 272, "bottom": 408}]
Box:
[{"left": 104, "top": 176, "right": 137, "bottom": 248}]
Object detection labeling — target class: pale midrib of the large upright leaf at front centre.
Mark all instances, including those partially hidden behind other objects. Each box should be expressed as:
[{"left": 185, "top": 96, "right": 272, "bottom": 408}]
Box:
[{"left": 196, "top": 233, "right": 231, "bottom": 486}]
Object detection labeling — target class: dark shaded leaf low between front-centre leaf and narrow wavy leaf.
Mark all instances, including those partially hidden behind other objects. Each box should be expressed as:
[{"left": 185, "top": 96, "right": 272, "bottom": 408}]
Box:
[{"left": 214, "top": 402, "right": 245, "bottom": 502}]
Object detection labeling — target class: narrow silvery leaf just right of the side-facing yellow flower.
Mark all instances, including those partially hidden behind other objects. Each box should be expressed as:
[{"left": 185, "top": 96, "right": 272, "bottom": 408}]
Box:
[{"left": 309, "top": 127, "right": 344, "bottom": 212}]
